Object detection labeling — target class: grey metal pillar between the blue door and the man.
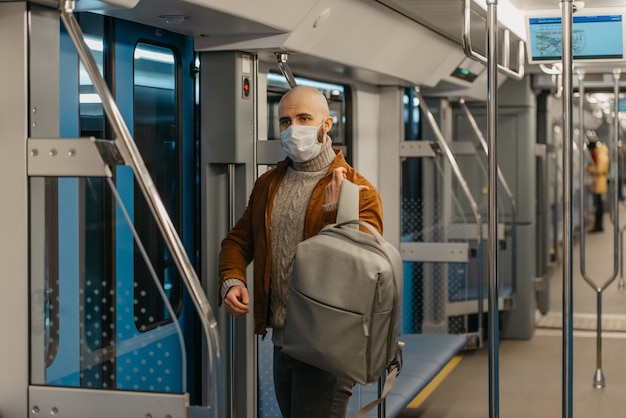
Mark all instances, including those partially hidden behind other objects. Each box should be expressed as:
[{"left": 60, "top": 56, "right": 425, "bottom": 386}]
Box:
[{"left": 200, "top": 52, "right": 258, "bottom": 417}]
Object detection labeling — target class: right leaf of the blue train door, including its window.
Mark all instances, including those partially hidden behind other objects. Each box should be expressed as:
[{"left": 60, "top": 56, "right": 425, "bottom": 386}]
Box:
[{"left": 115, "top": 16, "right": 196, "bottom": 391}]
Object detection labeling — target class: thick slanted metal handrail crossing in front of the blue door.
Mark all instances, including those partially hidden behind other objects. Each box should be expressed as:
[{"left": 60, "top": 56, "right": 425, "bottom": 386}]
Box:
[{"left": 59, "top": 1, "right": 220, "bottom": 418}]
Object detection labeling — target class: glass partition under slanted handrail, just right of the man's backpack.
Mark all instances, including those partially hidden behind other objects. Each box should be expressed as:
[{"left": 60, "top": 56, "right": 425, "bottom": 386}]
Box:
[{"left": 401, "top": 89, "right": 487, "bottom": 342}]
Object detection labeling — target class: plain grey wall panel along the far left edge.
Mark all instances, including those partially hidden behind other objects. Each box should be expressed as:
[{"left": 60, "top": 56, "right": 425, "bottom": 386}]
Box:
[{"left": 0, "top": 2, "right": 29, "bottom": 418}]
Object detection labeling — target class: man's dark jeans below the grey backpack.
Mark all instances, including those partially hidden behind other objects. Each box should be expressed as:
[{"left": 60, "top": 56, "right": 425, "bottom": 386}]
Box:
[{"left": 274, "top": 346, "right": 355, "bottom": 418}]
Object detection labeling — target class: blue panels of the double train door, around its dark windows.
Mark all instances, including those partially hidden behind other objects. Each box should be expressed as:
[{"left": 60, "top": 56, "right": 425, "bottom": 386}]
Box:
[{"left": 46, "top": 15, "right": 196, "bottom": 392}]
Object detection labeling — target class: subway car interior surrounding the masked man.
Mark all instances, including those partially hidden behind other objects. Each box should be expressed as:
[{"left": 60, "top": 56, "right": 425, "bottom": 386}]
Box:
[{"left": 0, "top": 0, "right": 626, "bottom": 418}]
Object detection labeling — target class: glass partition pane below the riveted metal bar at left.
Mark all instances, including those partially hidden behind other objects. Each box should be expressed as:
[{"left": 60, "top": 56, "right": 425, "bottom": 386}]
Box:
[{"left": 31, "top": 178, "right": 186, "bottom": 392}]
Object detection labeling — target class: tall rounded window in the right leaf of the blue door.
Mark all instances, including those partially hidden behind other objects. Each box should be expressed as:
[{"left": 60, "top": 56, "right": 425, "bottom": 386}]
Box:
[{"left": 133, "top": 43, "right": 182, "bottom": 331}]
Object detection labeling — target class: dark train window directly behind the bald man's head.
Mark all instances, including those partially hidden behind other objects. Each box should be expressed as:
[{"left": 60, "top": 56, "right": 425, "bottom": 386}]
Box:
[{"left": 267, "top": 72, "right": 352, "bottom": 163}]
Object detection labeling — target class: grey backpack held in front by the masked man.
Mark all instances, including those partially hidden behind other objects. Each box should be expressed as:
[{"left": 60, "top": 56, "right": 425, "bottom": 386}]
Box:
[{"left": 283, "top": 180, "right": 403, "bottom": 385}]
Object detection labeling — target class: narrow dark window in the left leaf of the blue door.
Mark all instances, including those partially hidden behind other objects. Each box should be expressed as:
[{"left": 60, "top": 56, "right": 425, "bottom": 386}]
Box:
[{"left": 78, "top": 13, "right": 115, "bottom": 387}]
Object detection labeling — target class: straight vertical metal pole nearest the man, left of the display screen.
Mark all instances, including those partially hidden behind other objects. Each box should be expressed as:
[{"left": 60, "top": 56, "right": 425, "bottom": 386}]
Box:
[{"left": 487, "top": 0, "right": 500, "bottom": 418}]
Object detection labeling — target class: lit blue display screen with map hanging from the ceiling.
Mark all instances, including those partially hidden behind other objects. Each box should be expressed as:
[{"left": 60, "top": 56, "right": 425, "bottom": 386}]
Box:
[{"left": 527, "top": 14, "right": 624, "bottom": 64}]
